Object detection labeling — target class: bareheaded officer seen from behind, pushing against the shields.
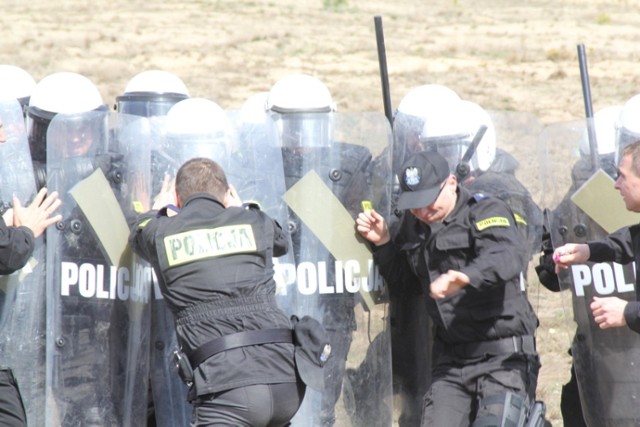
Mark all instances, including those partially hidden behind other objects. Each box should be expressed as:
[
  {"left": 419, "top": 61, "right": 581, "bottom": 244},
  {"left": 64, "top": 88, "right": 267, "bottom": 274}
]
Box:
[{"left": 129, "top": 158, "right": 330, "bottom": 426}]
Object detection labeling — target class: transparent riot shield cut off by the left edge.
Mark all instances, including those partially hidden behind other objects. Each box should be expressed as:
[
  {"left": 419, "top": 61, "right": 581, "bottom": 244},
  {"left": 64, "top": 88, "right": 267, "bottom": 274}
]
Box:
[{"left": 0, "top": 100, "right": 46, "bottom": 426}]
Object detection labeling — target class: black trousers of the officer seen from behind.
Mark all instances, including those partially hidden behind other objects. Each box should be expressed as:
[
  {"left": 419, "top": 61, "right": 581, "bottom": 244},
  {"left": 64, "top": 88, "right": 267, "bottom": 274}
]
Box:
[{"left": 190, "top": 381, "right": 306, "bottom": 427}]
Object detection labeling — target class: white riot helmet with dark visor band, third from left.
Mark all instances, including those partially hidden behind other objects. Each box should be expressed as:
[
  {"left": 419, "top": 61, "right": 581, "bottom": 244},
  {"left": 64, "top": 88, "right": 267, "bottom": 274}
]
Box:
[{"left": 115, "top": 70, "right": 189, "bottom": 117}]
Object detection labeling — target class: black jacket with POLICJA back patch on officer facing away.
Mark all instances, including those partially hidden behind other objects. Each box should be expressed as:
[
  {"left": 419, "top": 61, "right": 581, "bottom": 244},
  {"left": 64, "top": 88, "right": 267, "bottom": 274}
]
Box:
[{"left": 130, "top": 194, "right": 301, "bottom": 424}]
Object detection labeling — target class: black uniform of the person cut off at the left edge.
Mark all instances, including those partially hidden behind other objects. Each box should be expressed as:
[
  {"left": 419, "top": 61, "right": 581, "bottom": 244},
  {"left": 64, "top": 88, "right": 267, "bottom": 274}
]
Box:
[{"left": 0, "top": 217, "right": 35, "bottom": 426}]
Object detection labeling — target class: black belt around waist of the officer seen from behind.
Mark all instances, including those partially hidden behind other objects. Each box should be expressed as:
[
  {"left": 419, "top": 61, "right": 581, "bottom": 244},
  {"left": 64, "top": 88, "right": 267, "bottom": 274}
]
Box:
[{"left": 189, "top": 328, "right": 293, "bottom": 369}]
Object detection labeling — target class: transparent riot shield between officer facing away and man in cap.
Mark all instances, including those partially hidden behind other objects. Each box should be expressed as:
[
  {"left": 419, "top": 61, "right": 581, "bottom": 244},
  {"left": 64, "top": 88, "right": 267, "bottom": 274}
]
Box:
[{"left": 279, "top": 113, "right": 393, "bottom": 426}]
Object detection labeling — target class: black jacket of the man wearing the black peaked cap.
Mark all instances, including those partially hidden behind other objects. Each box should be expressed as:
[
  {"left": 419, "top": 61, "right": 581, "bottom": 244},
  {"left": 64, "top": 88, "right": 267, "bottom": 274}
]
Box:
[{"left": 374, "top": 187, "right": 538, "bottom": 344}]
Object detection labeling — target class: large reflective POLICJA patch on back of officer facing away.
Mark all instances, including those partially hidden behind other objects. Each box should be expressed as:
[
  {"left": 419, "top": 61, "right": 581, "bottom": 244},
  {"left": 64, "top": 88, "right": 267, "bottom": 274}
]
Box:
[{"left": 164, "top": 224, "right": 257, "bottom": 267}]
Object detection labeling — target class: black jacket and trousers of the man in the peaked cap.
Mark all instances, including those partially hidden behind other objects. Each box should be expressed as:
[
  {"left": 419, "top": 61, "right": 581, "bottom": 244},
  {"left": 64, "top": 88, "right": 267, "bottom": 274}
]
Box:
[{"left": 374, "top": 187, "right": 539, "bottom": 426}]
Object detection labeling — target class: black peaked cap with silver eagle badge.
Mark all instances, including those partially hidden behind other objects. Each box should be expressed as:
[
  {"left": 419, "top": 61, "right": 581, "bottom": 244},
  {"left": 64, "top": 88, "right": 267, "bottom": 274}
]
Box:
[{"left": 398, "top": 151, "right": 451, "bottom": 210}]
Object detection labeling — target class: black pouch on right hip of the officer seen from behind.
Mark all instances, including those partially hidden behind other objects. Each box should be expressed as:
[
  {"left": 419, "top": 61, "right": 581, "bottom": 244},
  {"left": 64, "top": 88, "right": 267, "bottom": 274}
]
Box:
[{"left": 291, "top": 316, "right": 331, "bottom": 391}]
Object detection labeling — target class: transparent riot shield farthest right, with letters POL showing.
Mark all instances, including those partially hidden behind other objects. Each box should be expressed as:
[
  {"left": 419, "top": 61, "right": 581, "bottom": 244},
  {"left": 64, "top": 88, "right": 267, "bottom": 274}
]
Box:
[{"left": 540, "top": 121, "right": 640, "bottom": 426}]
